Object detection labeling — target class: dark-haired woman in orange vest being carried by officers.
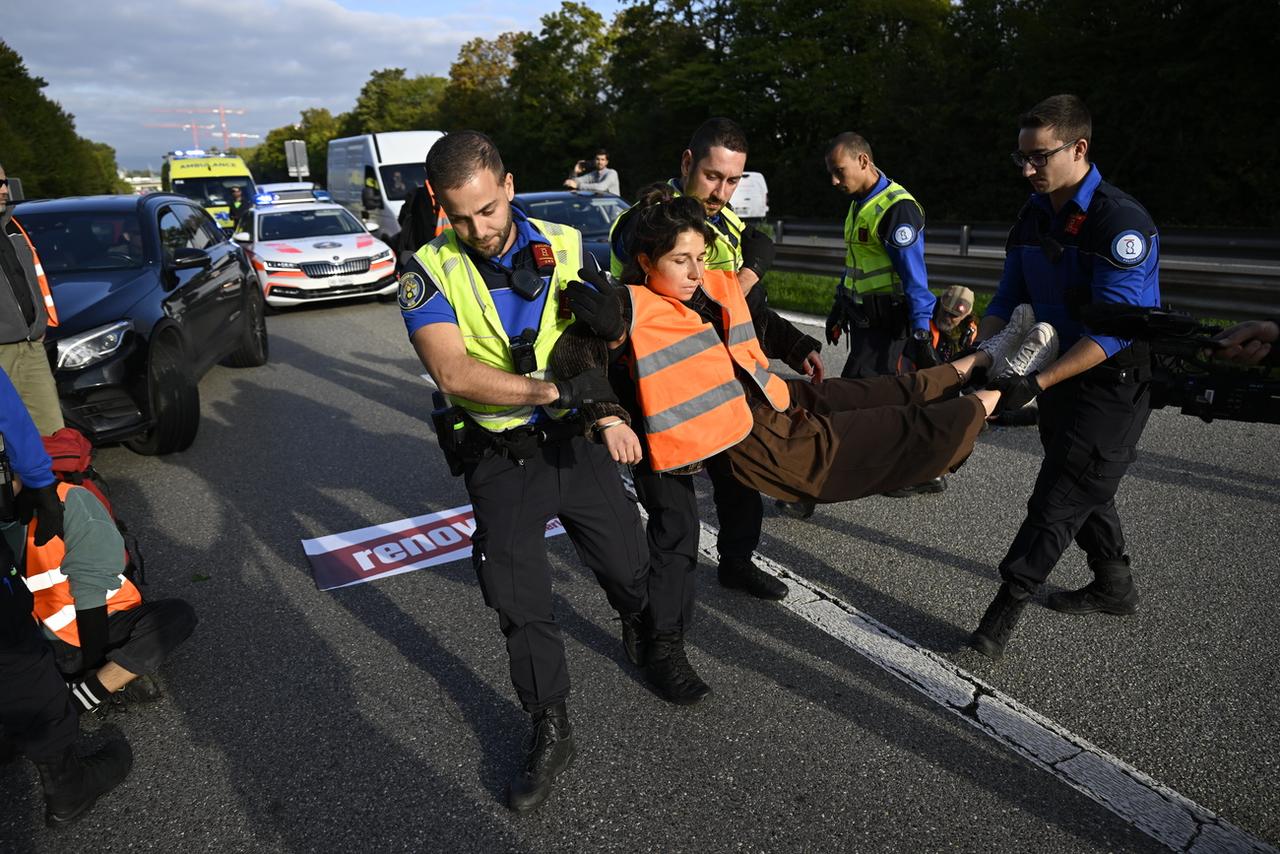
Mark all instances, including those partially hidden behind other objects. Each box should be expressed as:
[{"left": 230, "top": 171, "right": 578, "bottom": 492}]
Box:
[{"left": 553, "top": 188, "right": 1000, "bottom": 503}]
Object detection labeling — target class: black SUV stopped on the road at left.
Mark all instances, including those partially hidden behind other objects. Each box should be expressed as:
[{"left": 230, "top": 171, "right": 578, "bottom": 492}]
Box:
[{"left": 14, "top": 193, "right": 268, "bottom": 455}]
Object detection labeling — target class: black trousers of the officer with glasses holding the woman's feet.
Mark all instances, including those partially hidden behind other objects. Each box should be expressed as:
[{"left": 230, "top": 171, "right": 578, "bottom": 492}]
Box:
[{"left": 1000, "top": 369, "right": 1151, "bottom": 593}]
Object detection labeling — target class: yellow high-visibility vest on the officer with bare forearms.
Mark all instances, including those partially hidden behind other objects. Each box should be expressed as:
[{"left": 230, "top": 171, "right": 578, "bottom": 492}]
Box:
[{"left": 417, "top": 219, "right": 582, "bottom": 433}]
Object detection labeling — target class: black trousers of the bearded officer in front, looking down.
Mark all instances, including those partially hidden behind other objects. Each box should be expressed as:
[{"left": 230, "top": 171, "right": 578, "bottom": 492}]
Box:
[{"left": 463, "top": 435, "right": 648, "bottom": 713}]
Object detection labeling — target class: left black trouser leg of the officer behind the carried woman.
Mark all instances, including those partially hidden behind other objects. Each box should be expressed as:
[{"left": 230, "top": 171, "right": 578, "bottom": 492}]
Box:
[{"left": 634, "top": 462, "right": 701, "bottom": 631}]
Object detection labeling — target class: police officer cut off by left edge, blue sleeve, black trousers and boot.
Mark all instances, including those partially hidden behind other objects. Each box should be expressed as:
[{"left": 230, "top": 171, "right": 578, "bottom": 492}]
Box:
[{"left": 0, "top": 371, "right": 133, "bottom": 827}]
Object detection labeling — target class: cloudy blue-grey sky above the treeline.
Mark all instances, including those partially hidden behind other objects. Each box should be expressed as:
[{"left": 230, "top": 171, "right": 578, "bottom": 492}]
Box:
[{"left": 0, "top": 0, "right": 621, "bottom": 169}]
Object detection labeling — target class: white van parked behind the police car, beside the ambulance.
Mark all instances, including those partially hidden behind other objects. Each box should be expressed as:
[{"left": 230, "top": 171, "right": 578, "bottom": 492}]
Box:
[{"left": 329, "top": 131, "right": 444, "bottom": 241}]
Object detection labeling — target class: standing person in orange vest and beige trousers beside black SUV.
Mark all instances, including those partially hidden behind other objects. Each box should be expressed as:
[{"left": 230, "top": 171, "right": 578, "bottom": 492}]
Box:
[{"left": 0, "top": 166, "right": 64, "bottom": 435}]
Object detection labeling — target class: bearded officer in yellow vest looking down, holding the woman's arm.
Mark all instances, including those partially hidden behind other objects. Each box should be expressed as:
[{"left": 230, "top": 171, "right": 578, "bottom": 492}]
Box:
[{"left": 399, "top": 131, "right": 648, "bottom": 810}]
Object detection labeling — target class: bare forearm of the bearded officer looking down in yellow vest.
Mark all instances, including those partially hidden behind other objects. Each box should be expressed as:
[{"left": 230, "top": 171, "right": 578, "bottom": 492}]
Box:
[{"left": 411, "top": 323, "right": 559, "bottom": 406}]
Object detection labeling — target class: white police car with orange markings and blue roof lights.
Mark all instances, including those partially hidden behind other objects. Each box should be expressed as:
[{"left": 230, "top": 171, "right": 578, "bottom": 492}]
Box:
[{"left": 234, "top": 189, "right": 397, "bottom": 307}]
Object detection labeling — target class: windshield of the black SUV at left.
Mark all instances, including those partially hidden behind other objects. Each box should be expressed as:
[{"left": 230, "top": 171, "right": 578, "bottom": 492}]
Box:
[{"left": 17, "top": 210, "right": 147, "bottom": 275}]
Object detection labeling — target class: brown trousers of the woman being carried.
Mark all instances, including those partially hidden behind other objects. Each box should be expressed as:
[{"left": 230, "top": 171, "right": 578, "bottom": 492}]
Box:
[{"left": 724, "top": 365, "right": 986, "bottom": 503}]
